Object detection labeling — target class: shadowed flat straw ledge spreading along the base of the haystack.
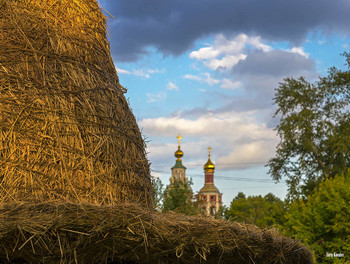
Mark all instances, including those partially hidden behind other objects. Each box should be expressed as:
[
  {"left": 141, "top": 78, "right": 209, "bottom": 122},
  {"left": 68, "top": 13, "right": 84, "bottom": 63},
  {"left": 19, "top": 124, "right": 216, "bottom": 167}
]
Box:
[{"left": 0, "top": 203, "right": 313, "bottom": 264}]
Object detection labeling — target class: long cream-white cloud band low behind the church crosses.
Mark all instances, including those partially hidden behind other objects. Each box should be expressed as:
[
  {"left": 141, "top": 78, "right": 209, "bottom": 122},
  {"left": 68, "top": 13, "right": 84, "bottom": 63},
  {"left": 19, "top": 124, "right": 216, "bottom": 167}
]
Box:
[{"left": 139, "top": 112, "right": 278, "bottom": 169}]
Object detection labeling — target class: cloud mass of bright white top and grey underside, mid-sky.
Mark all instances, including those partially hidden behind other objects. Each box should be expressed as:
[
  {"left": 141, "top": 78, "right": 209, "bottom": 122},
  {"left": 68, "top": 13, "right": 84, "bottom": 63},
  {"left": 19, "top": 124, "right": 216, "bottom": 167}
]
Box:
[{"left": 184, "top": 38, "right": 316, "bottom": 113}]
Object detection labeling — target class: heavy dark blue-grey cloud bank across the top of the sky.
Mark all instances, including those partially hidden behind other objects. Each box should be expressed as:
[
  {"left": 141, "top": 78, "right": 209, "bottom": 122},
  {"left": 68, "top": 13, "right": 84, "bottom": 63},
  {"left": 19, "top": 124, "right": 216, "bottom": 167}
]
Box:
[{"left": 101, "top": 0, "right": 350, "bottom": 61}]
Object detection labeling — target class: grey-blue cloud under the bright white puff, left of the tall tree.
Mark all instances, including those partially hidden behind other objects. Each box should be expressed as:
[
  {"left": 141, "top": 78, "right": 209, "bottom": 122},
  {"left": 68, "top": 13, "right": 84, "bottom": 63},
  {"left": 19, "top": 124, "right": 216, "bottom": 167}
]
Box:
[{"left": 183, "top": 50, "right": 317, "bottom": 118}]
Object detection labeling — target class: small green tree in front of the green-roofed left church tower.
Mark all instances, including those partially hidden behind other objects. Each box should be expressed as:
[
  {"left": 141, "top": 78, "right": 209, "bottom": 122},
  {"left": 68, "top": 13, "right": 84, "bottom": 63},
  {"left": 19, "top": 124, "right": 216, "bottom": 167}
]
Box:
[{"left": 163, "top": 180, "right": 201, "bottom": 215}]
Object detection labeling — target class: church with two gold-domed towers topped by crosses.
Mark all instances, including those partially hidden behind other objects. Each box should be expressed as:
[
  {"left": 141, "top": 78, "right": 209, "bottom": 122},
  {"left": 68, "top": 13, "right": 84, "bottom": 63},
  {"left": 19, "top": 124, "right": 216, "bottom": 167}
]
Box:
[{"left": 169, "top": 134, "right": 222, "bottom": 216}]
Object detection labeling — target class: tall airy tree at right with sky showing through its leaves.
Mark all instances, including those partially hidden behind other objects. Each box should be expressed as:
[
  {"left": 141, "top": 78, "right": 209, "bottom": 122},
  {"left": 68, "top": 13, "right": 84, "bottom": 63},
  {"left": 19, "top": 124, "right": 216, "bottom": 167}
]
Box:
[{"left": 268, "top": 53, "right": 350, "bottom": 200}]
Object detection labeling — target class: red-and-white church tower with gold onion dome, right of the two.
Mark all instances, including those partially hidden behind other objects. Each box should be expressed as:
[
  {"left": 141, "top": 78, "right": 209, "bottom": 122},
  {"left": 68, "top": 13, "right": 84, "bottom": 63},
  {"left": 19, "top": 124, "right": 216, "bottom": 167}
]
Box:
[{"left": 197, "top": 147, "right": 222, "bottom": 215}]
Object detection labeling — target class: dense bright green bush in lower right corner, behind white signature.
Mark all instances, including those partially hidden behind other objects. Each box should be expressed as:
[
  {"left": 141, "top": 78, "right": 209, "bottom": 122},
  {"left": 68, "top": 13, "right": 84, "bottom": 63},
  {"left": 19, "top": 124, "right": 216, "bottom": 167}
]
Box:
[{"left": 284, "top": 172, "right": 350, "bottom": 263}]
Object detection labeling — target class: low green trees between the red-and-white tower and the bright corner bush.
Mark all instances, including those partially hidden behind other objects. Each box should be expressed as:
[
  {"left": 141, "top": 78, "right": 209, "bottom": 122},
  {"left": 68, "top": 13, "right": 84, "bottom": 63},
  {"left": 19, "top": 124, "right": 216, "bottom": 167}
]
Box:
[{"left": 225, "top": 192, "right": 285, "bottom": 228}]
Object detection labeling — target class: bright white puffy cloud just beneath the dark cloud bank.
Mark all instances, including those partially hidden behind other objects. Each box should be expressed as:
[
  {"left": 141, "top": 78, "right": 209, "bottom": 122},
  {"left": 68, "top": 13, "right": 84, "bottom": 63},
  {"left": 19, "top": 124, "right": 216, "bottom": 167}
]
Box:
[{"left": 190, "top": 34, "right": 271, "bottom": 70}]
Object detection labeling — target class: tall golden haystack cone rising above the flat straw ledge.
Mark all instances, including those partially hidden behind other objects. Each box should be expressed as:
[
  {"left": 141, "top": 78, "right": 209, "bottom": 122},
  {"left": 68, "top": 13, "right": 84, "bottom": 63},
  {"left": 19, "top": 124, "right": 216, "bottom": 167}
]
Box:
[{"left": 0, "top": 0, "right": 151, "bottom": 206}]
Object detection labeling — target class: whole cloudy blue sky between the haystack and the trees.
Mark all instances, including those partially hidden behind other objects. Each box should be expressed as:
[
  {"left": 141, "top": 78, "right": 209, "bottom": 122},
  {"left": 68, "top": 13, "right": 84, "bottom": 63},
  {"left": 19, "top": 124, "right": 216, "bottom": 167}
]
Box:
[{"left": 99, "top": 0, "right": 350, "bottom": 205}]
